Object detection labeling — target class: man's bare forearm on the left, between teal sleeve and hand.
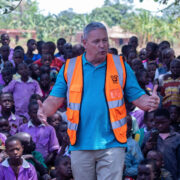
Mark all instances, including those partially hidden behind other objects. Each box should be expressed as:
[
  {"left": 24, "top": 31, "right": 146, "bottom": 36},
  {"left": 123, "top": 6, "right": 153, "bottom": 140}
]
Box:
[{"left": 43, "top": 96, "right": 65, "bottom": 117}]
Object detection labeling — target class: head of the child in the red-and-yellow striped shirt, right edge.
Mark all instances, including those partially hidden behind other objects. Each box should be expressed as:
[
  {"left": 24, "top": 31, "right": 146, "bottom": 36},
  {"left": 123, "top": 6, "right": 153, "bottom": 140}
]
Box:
[{"left": 170, "top": 59, "right": 180, "bottom": 78}]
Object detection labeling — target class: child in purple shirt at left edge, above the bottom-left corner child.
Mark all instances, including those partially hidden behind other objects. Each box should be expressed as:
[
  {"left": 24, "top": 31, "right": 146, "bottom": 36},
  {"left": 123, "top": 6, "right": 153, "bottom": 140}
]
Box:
[{"left": 0, "top": 92, "right": 22, "bottom": 135}]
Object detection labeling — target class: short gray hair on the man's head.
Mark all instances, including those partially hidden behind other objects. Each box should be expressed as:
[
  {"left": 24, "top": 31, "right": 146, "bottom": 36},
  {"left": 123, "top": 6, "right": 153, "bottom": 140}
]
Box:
[{"left": 83, "top": 22, "right": 107, "bottom": 39}]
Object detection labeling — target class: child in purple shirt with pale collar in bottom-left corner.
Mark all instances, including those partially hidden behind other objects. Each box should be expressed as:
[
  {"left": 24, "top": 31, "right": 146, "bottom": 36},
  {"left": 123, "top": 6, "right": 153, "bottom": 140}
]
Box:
[{"left": 0, "top": 136, "right": 37, "bottom": 180}]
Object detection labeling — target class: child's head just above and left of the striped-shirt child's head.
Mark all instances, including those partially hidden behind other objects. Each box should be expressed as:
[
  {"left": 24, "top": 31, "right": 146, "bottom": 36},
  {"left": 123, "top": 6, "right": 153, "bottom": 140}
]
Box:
[{"left": 162, "top": 48, "right": 175, "bottom": 68}]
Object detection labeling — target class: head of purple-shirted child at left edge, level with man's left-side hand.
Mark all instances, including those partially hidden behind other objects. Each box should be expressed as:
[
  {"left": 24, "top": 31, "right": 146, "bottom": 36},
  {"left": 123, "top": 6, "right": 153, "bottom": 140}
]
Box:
[{"left": 0, "top": 92, "right": 14, "bottom": 112}]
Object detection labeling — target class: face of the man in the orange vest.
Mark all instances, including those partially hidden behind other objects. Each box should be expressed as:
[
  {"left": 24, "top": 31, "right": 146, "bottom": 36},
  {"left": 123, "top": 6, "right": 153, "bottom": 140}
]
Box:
[{"left": 83, "top": 29, "right": 109, "bottom": 62}]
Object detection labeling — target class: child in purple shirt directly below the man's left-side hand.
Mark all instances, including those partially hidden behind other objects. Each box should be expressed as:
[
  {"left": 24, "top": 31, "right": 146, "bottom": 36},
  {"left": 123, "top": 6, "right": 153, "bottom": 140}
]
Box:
[{"left": 20, "top": 102, "right": 59, "bottom": 164}]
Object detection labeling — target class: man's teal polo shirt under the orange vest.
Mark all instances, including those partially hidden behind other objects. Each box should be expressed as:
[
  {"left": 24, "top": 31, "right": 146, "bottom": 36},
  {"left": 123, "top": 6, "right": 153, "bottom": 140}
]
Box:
[{"left": 50, "top": 54, "right": 145, "bottom": 151}]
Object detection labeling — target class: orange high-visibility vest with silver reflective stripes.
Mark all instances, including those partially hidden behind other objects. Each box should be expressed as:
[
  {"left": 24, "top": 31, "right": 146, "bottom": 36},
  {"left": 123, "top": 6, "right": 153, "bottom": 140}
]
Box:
[{"left": 64, "top": 54, "right": 127, "bottom": 145}]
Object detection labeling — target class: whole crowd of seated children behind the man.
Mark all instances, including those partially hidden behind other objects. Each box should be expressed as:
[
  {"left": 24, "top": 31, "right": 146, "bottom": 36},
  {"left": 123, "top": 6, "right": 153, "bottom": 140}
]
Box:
[{"left": 0, "top": 34, "right": 180, "bottom": 180}]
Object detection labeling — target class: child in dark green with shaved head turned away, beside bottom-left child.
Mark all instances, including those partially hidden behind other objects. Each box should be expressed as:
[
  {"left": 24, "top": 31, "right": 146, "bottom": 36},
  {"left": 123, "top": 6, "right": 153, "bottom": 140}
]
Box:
[{"left": 14, "top": 132, "right": 50, "bottom": 180}]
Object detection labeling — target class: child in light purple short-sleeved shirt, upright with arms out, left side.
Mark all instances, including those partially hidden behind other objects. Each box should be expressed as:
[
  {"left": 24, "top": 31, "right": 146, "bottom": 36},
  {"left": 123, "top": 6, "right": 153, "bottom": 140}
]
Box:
[{"left": 2, "top": 63, "right": 42, "bottom": 117}]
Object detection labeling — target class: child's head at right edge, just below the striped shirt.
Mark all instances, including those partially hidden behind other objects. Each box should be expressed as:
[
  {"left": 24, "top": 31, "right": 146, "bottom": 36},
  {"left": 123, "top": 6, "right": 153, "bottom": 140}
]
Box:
[{"left": 168, "top": 105, "right": 180, "bottom": 123}]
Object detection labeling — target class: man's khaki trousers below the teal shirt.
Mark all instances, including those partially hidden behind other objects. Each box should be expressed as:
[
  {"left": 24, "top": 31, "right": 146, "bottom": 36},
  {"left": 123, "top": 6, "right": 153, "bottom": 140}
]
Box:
[{"left": 71, "top": 147, "right": 125, "bottom": 180}]
